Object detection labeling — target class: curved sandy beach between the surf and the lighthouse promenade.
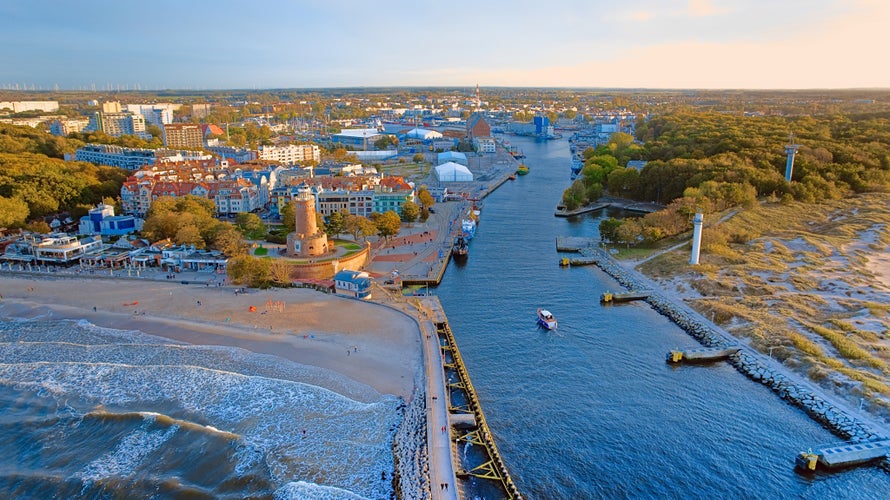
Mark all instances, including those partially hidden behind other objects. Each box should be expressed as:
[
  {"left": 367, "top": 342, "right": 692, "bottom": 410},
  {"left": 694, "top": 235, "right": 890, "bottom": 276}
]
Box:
[{"left": 0, "top": 275, "right": 422, "bottom": 401}]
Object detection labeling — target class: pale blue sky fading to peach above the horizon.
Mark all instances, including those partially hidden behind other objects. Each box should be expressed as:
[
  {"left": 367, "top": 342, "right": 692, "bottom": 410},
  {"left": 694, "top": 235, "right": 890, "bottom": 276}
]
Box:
[{"left": 0, "top": 0, "right": 890, "bottom": 90}]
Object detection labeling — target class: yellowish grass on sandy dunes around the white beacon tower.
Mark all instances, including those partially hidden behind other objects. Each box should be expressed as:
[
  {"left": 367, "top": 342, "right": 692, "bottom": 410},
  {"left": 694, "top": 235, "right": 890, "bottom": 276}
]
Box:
[{"left": 618, "top": 193, "right": 890, "bottom": 415}]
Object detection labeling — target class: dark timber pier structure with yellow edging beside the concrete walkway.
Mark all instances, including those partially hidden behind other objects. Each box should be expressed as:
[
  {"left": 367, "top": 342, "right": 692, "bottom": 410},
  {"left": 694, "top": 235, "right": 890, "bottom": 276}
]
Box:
[{"left": 422, "top": 297, "right": 522, "bottom": 499}]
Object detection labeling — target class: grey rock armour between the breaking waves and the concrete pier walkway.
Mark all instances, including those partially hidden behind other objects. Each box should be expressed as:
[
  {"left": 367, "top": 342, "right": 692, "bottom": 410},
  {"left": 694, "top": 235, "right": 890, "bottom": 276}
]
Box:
[{"left": 392, "top": 380, "right": 432, "bottom": 500}]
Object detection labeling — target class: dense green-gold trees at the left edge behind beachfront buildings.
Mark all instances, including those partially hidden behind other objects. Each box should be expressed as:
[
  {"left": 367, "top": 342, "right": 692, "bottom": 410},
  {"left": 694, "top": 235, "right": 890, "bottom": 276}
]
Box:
[{"left": 0, "top": 125, "right": 127, "bottom": 232}]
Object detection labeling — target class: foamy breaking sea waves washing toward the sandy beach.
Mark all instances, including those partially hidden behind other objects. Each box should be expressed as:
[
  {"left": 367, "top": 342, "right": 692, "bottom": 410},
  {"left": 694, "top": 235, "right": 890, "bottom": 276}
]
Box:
[{"left": 0, "top": 318, "right": 402, "bottom": 499}]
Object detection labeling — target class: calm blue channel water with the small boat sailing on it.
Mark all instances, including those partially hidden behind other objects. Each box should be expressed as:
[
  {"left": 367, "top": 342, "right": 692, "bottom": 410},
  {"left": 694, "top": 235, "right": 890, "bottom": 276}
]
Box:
[{"left": 434, "top": 136, "right": 890, "bottom": 499}]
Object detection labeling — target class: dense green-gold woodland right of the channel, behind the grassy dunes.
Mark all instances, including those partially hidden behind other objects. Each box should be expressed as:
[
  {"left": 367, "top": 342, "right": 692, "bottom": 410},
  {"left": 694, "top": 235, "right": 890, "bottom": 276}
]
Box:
[{"left": 563, "top": 112, "right": 890, "bottom": 245}]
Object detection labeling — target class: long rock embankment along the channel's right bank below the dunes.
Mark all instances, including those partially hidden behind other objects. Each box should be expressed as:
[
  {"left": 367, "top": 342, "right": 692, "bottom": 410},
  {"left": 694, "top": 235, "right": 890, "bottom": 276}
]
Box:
[{"left": 581, "top": 247, "right": 887, "bottom": 443}]
